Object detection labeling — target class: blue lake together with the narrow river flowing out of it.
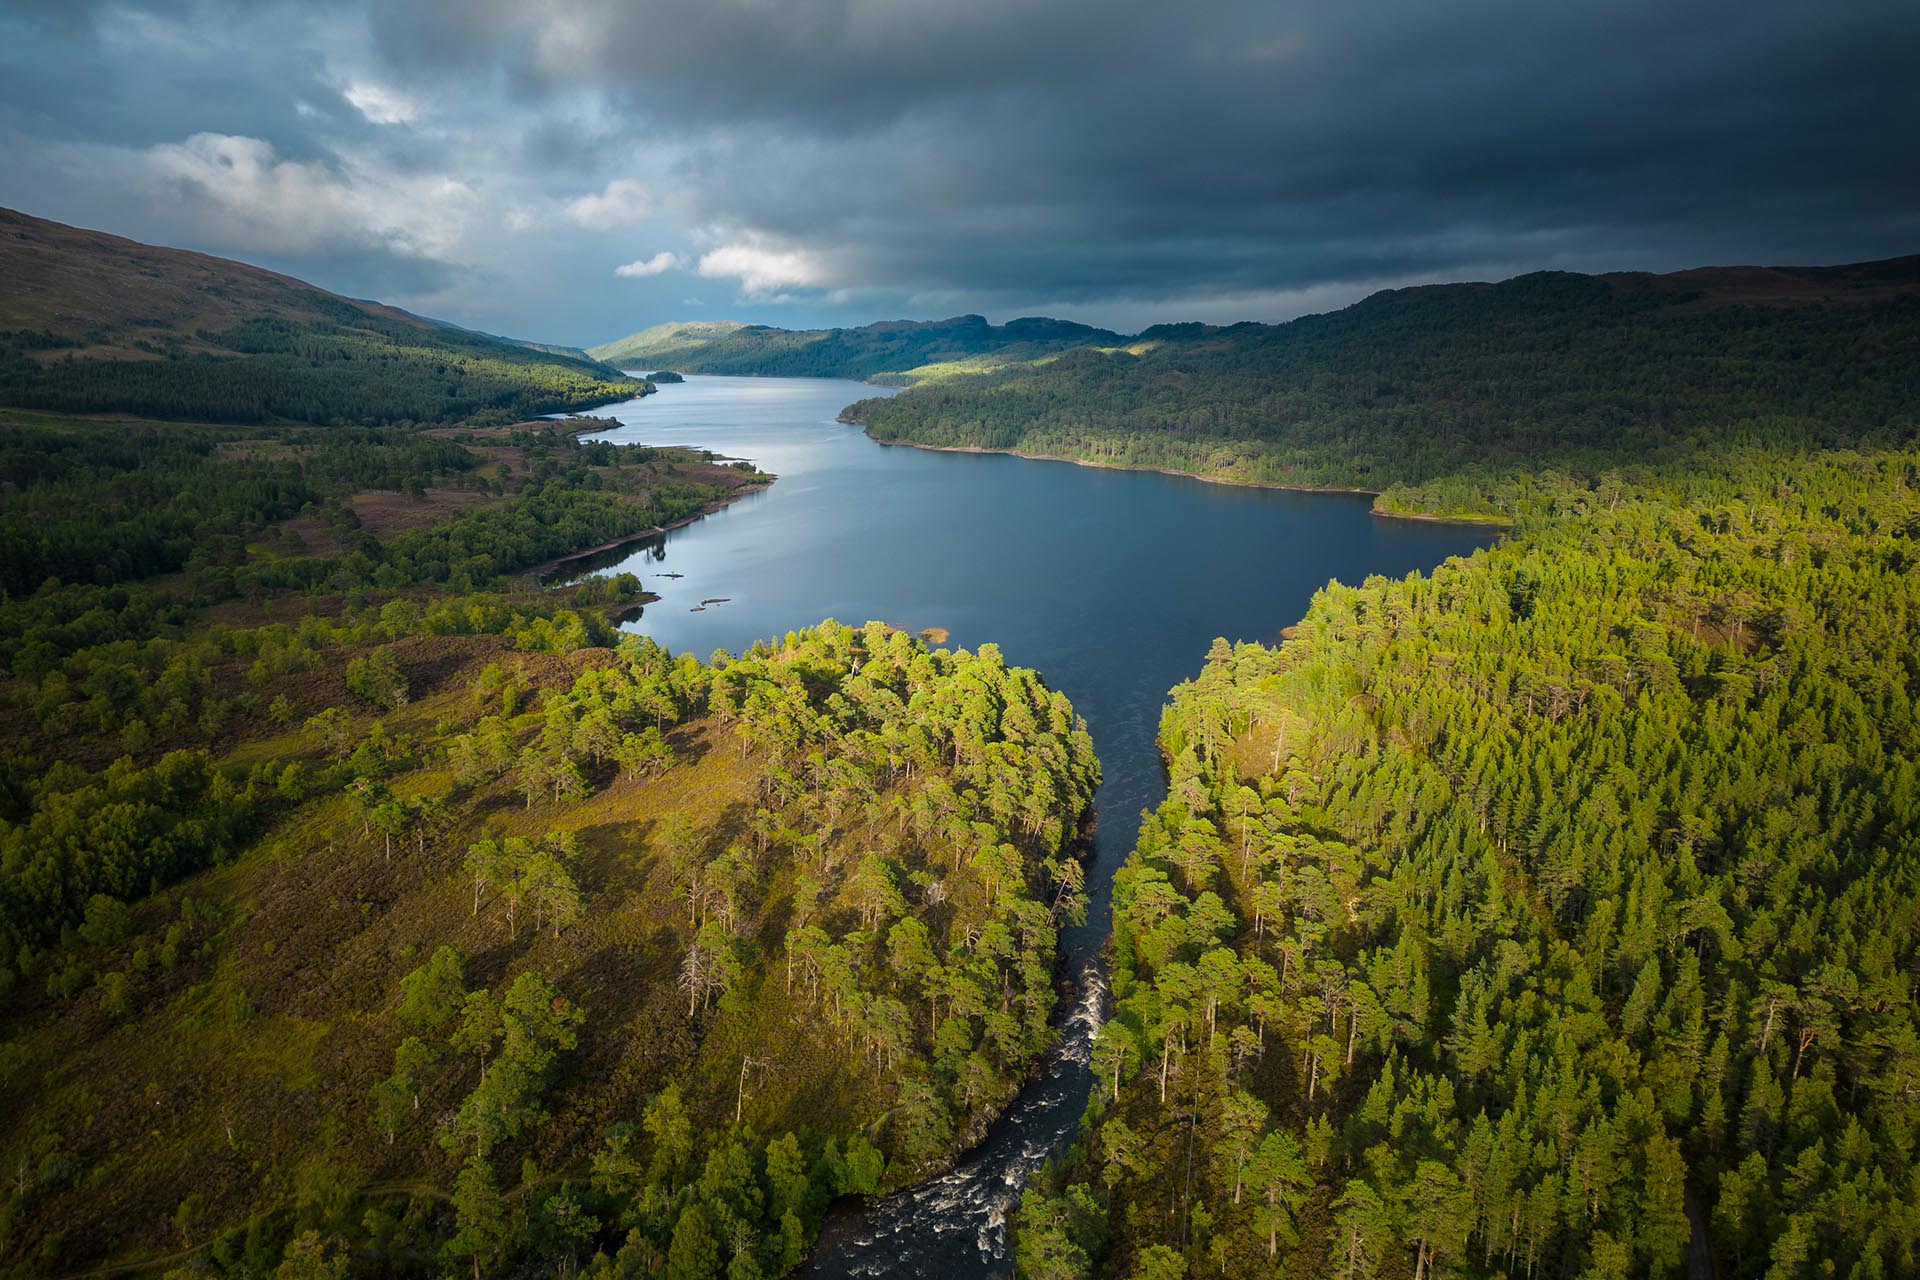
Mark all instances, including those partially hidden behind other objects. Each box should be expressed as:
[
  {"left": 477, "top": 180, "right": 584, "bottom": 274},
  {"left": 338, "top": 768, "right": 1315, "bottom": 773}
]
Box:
[{"left": 560, "top": 378, "right": 1494, "bottom": 1276}]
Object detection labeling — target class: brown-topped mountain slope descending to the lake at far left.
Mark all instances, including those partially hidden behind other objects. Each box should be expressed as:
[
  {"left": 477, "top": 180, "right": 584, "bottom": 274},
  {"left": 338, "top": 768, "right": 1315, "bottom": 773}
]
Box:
[{"left": 0, "top": 209, "right": 645, "bottom": 424}]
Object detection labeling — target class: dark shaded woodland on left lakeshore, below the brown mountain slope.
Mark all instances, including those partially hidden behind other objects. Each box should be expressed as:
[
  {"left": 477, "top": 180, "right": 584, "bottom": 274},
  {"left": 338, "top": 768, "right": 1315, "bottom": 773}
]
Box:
[{"left": 0, "top": 411, "right": 770, "bottom": 687}]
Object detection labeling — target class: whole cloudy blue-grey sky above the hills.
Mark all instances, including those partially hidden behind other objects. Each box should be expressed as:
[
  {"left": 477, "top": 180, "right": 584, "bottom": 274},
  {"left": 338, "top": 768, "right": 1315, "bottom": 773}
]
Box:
[{"left": 0, "top": 0, "right": 1920, "bottom": 345}]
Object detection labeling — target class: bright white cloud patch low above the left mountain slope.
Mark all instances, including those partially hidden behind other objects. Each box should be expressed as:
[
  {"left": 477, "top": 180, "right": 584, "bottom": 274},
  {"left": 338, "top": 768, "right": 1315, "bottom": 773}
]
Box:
[{"left": 137, "top": 132, "right": 476, "bottom": 257}]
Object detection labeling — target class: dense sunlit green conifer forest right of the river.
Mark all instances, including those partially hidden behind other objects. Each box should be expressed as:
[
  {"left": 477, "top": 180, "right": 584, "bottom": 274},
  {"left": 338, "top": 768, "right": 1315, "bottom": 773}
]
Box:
[{"left": 1018, "top": 451, "right": 1920, "bottom": 1280}]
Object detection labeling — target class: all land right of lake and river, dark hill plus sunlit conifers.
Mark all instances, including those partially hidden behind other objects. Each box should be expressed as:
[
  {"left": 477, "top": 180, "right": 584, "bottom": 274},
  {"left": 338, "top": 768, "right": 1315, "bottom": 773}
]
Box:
[{"left": 1006, "top": 259, "right": 1920, "bottom": 1280}]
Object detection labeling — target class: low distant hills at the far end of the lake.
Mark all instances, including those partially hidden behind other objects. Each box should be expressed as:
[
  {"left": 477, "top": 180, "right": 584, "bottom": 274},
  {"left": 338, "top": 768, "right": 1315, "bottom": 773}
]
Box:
[{"left": 588, "top": 315, "right": 1125, "bottom": 380}]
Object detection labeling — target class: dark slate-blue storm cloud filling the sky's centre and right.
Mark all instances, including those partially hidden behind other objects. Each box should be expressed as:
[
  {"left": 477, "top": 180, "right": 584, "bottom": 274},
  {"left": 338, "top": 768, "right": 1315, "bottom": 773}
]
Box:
[{"left": 357, "top": 0, "right": 1920, "bottom": 320}]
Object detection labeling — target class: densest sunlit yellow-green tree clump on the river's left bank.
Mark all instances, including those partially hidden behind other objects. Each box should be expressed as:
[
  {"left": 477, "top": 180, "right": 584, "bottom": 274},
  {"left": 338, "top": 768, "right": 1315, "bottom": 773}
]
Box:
[{"left": 648, "top": 624, "right": 1098, "bottom": 1169}]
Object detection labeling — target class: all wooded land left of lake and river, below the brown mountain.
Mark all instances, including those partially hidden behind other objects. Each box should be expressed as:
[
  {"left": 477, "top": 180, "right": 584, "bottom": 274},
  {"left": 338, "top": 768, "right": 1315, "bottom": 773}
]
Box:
[{"left": 0, "top": 404, "right": 1098, "bottom": 1276}]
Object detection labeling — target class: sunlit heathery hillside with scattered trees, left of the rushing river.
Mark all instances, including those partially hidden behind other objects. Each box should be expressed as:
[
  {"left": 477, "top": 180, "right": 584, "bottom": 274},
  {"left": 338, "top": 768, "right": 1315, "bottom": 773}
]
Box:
[{"left": 0, "top": 617, "right": 1098, "bottom": 1276}]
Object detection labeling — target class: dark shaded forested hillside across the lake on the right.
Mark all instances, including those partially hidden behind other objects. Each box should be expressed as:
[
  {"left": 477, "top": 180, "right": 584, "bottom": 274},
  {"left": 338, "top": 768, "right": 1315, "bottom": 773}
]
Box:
[{"left": 847, "top": 257, "right": 1920, "bottom": 516}]
